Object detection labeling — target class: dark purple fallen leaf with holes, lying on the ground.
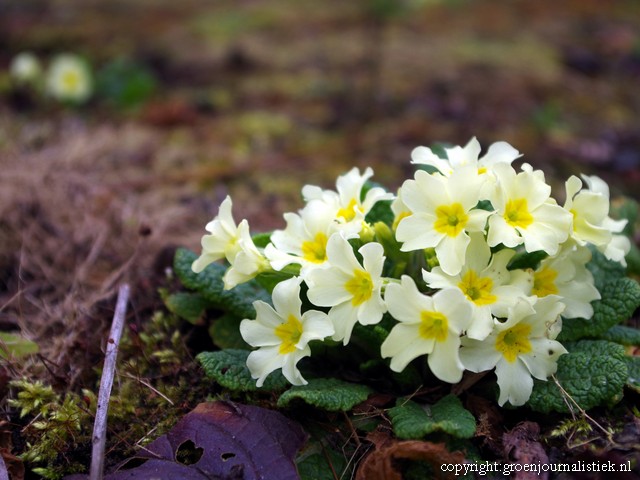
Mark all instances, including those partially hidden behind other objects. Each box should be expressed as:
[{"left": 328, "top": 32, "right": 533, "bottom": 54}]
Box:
[{"left": 67, "top": 402, "right": 307, "bottom": 480}]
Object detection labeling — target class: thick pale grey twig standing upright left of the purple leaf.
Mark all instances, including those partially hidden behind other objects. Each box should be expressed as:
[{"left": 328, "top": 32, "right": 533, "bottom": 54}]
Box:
[{"left": 89, "top": 284, "right": 129, "bottom": 480}]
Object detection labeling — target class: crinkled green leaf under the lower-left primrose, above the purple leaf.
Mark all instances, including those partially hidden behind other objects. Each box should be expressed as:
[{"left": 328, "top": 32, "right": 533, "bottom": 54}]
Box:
[{"left": 196, "top": 349, "right": 288, "bottom": 392}]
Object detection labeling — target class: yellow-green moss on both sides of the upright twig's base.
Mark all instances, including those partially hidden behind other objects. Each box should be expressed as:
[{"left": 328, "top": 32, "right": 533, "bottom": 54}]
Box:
[{"left": 9, "top": 312, "right": 211, "bottom": 479}]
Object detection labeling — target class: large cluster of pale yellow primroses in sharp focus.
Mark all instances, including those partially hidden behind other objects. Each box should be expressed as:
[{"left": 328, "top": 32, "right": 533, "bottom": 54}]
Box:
[{"left": 192, "top": 138, "right": 630, "bottom": 405}]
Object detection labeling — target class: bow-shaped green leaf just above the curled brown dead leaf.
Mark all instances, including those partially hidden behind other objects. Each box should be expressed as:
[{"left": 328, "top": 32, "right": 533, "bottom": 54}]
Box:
[{"left": 388, "top": 394, "right": 476, "bottom": 440}]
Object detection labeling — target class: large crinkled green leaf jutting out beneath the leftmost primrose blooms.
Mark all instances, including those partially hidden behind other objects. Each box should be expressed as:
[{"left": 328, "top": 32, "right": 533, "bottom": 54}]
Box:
[{"left": 173, "top": 248, "right": 271, "bottom": 318}]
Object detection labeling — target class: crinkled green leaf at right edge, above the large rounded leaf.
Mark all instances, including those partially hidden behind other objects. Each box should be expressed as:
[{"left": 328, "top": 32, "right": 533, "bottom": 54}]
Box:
[{"left": 558, "top": 277, "right": 640, "bottom": 342}]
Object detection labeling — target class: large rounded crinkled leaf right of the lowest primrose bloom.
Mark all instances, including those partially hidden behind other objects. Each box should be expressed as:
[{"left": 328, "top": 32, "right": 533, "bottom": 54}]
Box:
[{"left": 528, "top": 340, "right": 628, "bottom": 413}]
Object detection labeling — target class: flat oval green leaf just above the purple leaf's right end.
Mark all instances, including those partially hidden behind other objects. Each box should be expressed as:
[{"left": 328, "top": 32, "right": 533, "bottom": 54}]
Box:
[{"left": 278, "top": 378, "right": 372, "bottom": 412}]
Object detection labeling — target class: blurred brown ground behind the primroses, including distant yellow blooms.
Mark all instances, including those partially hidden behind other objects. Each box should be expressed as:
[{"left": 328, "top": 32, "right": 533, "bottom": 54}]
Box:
[{"left": 0, "top": 0, "right": 640, "bottom": 378}]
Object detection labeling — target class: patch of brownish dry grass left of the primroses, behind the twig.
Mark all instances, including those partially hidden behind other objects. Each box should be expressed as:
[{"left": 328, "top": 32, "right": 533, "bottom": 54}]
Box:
[{"left": 0, "top": 118, "right": 222, "bottom": 388}]
